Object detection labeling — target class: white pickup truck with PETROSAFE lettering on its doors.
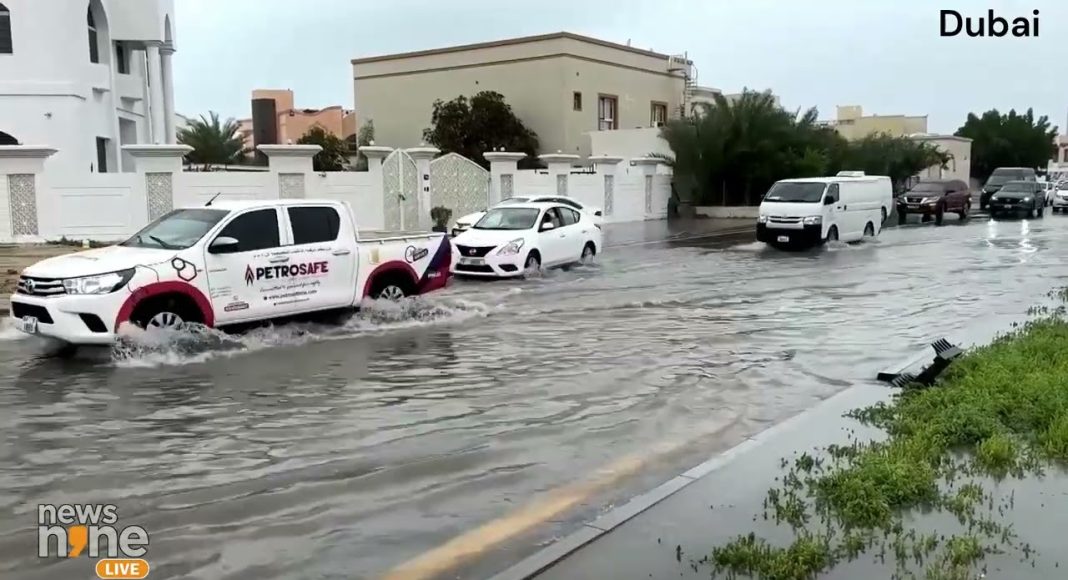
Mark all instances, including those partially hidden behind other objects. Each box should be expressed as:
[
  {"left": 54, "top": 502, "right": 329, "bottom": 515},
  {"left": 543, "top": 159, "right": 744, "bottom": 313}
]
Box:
[{"left": 11, "top": 200, "right": 452, "bottom": 345}]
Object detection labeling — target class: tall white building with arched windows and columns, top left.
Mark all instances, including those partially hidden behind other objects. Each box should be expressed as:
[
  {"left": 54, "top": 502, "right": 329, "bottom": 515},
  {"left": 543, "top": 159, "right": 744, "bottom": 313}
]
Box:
[{"left": 0, "top": 0, "right": 175, "bottom": 172}]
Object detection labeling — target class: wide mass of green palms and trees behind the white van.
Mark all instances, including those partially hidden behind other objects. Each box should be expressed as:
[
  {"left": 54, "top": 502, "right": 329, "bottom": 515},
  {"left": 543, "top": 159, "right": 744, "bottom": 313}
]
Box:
[{"left": 661, "top": 90, "right": 948, "bottom": 205}]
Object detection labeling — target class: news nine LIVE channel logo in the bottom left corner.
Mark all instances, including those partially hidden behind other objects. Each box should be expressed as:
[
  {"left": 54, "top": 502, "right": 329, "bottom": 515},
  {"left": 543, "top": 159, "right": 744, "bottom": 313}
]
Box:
[{"left": 37, "top": 503, "right": 148, "bottom": 580}]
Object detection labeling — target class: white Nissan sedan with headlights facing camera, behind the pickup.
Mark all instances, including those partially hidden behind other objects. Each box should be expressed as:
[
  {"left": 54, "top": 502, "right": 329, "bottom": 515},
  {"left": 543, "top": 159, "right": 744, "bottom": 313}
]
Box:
[{"left": 453, "top": 202, "right": 601, "bottom": 278}]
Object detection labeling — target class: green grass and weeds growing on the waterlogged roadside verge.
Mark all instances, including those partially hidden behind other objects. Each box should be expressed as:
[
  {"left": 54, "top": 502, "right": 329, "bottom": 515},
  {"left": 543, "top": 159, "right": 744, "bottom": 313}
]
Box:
[{"left": 708, "top": 291, "right": 1068, "bottom": 580}]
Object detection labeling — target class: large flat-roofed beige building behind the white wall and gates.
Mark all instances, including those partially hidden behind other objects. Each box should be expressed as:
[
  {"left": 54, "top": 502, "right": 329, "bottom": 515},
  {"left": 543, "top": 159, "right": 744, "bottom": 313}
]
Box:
[{"left": 352, "top": 32, "right": 696, "bottom": 156}]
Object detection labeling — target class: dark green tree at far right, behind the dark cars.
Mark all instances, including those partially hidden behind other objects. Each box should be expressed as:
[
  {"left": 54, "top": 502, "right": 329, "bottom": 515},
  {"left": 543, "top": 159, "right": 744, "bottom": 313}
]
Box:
[{"left": 955, "top": 109, "right": 1057, "bottom": 179}]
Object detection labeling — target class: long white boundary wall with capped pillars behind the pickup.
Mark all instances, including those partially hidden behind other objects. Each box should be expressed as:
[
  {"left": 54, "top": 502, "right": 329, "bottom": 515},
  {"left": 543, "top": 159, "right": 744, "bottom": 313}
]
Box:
[{"left": 0, "top": 145, "right": 671, "bottom": 244}]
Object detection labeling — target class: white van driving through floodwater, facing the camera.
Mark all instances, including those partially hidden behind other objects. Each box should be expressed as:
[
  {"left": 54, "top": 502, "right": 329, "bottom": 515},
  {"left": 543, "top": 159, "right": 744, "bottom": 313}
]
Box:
[{"left": 756, "top": 172, "right": 894, "bottom": 247}]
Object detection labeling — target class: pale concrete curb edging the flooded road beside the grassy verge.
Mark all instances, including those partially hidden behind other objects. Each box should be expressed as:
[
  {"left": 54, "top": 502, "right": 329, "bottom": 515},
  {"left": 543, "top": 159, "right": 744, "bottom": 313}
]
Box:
[{"left": 489, "top": 346, "right": 931, "bottom": 580}]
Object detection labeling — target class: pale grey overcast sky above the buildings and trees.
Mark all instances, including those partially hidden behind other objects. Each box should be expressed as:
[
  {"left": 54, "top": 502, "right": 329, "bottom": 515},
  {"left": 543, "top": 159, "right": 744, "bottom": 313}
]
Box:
[{"left": 175, "top": 0, "right": 1068, "bottom": 132}]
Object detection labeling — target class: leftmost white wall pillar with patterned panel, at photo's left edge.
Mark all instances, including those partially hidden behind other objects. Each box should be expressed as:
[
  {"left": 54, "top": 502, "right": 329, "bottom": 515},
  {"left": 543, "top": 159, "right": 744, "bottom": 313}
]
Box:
[{"left": 0, "top": 145, "right": 56, "bottom": 242}]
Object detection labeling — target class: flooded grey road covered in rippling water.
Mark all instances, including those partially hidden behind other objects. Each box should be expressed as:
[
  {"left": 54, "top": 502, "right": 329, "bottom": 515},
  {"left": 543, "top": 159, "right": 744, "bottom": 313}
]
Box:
[{"left": 0, "top": 216, "right": 1068, "bottom": 579}]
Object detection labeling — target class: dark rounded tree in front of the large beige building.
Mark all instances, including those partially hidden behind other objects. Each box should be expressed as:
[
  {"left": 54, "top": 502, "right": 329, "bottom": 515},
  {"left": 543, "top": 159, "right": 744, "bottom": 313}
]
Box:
[{"left": 423, "top": 91, "right": 540, "bottom": 169}]
